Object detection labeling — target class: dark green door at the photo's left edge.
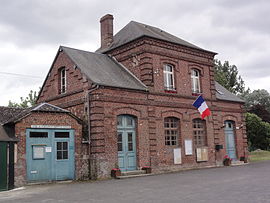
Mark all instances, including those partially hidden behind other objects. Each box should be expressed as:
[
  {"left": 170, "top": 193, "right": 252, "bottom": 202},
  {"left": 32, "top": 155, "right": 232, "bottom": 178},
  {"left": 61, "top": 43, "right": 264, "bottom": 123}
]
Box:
[{"left": 0, "top": 142, "right": 8, "bottom": 191}]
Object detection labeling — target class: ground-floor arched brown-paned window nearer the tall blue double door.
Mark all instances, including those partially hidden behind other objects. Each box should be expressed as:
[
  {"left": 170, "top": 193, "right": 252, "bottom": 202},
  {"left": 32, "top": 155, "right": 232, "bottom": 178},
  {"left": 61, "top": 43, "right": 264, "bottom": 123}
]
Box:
[{"left": 164, "top": 117, "right": 179, "bottom": 146}]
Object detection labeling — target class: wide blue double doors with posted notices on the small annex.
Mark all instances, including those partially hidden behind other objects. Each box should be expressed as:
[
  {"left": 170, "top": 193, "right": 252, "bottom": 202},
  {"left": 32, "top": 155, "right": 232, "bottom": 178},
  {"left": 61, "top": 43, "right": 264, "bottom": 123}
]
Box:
[{"left": 26, "top": 129, "right": 74, "bottom": 182}]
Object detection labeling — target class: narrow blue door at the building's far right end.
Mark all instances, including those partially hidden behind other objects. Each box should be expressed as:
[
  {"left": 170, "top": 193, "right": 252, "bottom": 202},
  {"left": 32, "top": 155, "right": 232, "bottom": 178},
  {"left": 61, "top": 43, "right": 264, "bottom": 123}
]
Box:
[{"left": 225, "top": 121, "right": 237, "bottom": 160}]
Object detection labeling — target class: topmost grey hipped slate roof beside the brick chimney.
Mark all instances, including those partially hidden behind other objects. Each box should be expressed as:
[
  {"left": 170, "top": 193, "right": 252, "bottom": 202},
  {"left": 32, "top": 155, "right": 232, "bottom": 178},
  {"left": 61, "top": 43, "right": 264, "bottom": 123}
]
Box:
[{"left": 96, "top": 21, "right": 216, "bottom": 54}]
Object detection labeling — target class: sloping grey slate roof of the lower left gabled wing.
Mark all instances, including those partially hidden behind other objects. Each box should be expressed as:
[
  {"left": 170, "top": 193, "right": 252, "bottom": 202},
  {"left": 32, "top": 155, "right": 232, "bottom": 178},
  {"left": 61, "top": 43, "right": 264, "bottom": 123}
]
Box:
[{"left": 60, "top": 46, "right": 147, "bottom": 91}]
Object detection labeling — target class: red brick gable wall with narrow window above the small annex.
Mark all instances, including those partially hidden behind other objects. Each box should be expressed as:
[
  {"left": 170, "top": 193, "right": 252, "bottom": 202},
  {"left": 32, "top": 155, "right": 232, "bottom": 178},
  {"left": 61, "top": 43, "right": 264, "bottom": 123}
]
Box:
[{"left": 37, "top": 51, "right": 90, "bottom": 119}]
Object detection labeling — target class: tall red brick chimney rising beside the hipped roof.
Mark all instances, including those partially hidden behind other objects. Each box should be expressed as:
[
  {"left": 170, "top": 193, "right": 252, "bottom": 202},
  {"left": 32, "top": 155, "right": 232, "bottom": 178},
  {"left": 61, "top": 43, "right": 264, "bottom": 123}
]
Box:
[{"left": 100, "top": 14, "right": 113, "bottom": 49}]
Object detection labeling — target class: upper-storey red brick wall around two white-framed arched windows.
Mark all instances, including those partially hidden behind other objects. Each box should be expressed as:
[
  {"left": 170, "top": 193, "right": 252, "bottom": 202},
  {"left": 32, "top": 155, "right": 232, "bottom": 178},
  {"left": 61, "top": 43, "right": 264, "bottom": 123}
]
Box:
[{"left": 105, "top": 38, "right": 215, "bottom": 98}]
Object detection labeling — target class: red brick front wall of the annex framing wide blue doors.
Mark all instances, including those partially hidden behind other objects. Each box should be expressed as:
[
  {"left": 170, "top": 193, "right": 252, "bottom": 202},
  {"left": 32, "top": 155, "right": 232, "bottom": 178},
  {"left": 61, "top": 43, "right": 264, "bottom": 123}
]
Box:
[{"left": 15, "top": 113, "right": 89, "bottom": 186}]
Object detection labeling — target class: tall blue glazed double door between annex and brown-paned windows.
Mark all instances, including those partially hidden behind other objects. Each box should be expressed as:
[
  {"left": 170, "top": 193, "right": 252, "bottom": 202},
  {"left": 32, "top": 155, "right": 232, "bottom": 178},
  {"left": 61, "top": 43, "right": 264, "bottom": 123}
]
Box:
[{"left": 117, "top": 115, "right": 137, "bottom": 171}]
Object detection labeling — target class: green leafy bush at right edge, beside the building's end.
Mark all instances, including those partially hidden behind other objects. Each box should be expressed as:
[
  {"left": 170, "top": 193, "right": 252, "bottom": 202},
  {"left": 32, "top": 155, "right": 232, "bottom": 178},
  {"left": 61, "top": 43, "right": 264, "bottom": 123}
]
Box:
[{"left": 246, "top": 113, "right": 270, "bottom": 150}]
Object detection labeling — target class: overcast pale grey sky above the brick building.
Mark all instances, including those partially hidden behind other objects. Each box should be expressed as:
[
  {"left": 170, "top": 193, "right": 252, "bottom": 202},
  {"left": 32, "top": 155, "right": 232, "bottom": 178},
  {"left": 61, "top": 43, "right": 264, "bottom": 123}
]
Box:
[{"left": 0, "top": 0, "right": 270, "bottom": 106}]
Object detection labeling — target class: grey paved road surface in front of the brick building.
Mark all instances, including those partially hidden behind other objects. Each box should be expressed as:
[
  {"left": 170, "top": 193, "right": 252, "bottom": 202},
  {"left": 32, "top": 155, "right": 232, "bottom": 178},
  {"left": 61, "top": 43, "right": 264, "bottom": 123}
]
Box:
[{"left": 0, "top": 161, "right": 270, "bottom": 203}]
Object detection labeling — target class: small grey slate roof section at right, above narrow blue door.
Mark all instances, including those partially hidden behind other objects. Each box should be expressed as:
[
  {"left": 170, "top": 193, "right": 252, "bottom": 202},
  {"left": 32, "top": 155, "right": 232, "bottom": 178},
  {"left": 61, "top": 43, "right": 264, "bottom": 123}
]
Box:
[{"left": 215, "top": 81, "right": 245, "bottom": 103}]
